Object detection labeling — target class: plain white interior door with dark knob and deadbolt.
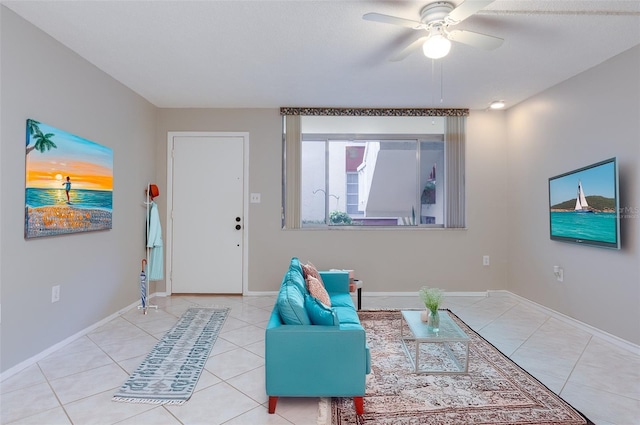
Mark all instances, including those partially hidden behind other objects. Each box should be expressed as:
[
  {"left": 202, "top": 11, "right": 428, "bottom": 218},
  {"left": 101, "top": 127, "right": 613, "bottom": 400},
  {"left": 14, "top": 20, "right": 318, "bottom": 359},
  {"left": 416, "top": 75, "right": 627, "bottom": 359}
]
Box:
[{"left": 170, "top": 134, "right": 245, "bottom": 294}]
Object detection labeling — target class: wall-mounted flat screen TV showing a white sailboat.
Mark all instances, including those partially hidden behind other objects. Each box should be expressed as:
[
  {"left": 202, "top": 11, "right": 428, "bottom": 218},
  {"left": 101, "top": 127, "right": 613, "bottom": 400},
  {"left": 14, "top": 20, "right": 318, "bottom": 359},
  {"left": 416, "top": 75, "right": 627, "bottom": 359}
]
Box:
[{"left": 549, "top": 158, "right": 620, "bottom": 249}]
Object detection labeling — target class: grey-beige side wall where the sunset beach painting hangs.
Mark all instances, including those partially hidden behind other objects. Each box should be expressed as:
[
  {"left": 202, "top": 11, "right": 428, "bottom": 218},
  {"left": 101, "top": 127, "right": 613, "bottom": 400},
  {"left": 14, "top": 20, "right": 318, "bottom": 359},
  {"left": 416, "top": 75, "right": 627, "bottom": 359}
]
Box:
[{"left": 0, "top": 6, "right": 157, "bottom": 371}]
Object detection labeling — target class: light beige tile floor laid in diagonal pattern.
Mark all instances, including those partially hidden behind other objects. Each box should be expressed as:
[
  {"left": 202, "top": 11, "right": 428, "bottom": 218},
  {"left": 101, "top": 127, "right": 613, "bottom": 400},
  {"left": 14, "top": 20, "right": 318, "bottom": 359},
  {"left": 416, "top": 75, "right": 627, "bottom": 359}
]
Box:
[{"left": 0, "top": 295, "right": 640, "bottom": 425}]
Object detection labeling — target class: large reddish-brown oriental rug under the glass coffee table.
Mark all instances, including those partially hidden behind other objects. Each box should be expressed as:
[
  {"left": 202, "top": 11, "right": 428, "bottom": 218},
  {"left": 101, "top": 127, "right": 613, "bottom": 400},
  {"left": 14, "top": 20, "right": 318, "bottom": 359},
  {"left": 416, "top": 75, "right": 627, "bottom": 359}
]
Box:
[{"left": 331, "top": 311, "right": 593, "bottom": 425}]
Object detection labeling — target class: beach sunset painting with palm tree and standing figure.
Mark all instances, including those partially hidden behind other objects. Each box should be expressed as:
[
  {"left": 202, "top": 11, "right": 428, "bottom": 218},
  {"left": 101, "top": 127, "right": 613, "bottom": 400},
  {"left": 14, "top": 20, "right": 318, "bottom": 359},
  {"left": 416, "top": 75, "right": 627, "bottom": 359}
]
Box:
[{"left": 24, "top": 119, "right": 113, "bottom": 239}]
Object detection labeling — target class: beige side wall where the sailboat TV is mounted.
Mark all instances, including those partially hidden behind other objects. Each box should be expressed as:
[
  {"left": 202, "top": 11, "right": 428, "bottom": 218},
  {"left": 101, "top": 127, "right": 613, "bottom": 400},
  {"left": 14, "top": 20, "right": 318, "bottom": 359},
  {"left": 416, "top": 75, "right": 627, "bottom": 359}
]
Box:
[{"left": 506, "top": 46, "right": 640, "bottom": 344}]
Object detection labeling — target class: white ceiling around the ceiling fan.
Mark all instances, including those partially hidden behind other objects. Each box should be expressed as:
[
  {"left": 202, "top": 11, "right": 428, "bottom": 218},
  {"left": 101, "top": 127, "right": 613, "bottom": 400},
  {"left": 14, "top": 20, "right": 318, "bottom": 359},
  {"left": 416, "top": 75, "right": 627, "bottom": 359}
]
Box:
[{"left": 2, "top": 0, "right": 640, "bottom": 109}]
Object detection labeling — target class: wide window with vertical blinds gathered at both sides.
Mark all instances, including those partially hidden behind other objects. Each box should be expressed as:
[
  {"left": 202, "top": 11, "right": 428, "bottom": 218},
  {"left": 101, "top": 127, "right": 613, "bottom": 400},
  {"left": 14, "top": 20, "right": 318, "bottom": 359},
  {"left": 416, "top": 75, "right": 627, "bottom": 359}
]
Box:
[{"left": 283, "top": 109, "right": 464, "bottom": 228}]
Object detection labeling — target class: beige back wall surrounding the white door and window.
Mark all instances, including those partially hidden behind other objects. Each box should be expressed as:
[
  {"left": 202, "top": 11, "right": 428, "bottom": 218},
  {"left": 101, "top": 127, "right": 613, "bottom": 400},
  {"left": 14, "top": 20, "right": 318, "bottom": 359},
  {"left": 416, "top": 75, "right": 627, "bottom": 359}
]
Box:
[{"left": 156, "top": 109, "right": 507, "bottom": 292}]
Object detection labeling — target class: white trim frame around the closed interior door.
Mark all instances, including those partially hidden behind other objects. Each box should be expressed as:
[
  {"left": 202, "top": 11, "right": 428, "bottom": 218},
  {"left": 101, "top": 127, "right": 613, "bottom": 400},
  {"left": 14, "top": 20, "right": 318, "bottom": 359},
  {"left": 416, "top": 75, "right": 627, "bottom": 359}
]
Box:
[{"left": 165, "top": 131, "right": 249, "bottom": 295}]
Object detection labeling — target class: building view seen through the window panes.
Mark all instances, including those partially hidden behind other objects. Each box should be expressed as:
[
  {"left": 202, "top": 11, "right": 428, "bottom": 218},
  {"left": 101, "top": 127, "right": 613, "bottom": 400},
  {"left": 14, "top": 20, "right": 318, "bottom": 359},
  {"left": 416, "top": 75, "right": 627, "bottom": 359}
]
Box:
[{"left": 300, "top": 135, "right": 444, "bottom": 227}]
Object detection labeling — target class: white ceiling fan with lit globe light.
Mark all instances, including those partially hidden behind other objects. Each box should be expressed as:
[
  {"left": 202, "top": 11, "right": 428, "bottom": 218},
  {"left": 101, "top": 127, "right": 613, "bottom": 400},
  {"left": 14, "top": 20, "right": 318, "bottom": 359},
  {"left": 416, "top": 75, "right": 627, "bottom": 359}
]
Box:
[{"left": 362, "top": 0, "right": 504, "bottom": 62}]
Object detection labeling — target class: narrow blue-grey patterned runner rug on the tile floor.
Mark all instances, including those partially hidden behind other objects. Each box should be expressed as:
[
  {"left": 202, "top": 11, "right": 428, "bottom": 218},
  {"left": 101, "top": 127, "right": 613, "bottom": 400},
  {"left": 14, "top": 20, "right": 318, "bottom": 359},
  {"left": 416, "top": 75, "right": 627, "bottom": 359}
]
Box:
[{"left": 113, "top": 308, "right": 229, "bottom": 404}]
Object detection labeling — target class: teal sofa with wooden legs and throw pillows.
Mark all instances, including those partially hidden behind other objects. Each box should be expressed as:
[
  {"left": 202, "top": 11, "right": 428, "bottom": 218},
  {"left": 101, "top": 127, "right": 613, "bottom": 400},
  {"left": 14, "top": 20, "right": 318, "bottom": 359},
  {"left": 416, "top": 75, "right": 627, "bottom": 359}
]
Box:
[{"left": 265, "top": 257, "right": 371, "bottom": 415}]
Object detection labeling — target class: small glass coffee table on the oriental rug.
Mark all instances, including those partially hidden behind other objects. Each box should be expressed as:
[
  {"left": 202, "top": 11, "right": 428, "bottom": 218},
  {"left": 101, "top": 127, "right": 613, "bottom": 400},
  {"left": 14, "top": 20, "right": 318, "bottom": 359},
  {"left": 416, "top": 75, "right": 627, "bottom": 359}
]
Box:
[{"left": 400, "top": 310, "right": 469, "bottom": 374}]
